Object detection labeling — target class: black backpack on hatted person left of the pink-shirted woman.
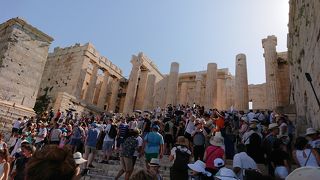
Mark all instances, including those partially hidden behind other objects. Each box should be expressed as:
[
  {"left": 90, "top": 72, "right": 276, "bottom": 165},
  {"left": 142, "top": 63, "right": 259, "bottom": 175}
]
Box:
[{"left": 172, "top": 148, "right": 190, "bottom": 171}]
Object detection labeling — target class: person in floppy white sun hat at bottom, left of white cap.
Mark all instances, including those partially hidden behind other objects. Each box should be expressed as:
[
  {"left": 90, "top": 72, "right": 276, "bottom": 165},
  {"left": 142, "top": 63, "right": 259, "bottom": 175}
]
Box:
[{"left": 188, "top": 160, "right": 212, "bottom": 180}]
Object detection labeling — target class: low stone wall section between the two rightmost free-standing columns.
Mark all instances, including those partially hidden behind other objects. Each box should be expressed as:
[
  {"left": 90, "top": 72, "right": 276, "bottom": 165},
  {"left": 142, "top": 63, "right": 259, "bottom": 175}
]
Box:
[{"left": 249, "top": 83, "right": 268, "bottom": 110}]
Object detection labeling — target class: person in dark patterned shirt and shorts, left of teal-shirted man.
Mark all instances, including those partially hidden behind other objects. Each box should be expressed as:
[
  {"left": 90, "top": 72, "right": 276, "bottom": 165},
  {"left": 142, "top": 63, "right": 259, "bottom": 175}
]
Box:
[{"left": 115, "top": 131, "right": 139, "bottom": 180}]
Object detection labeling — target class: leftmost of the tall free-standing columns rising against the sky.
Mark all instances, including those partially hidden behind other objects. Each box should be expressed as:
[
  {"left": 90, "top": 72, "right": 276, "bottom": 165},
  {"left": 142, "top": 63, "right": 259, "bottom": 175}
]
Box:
[{"left": 166, "top": 62, "right": 179, "bottom": 106}]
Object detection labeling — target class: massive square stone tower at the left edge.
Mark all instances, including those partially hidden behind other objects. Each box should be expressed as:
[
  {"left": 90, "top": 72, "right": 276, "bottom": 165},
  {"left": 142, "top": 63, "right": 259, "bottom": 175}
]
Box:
[{"left": 0, "top": 18, "right": 53, "bottom": 131}]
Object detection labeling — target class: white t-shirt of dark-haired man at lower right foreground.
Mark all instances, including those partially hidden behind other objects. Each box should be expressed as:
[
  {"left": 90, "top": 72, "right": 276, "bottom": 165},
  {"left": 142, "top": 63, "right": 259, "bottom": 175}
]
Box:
[{"left": 233, "top": 152, "right": 257, "bottom": 180}]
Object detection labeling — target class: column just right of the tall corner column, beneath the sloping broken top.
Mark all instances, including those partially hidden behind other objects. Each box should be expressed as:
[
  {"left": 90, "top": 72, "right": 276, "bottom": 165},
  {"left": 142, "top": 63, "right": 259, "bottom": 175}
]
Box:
[{"left": 134, "top": 70, "right": 149, "bottom": 110}]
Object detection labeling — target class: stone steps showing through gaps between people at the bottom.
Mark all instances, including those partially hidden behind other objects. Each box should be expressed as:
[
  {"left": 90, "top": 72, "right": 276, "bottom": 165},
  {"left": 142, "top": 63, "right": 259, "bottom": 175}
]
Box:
[{"left": 82, "top": 151, "right": 268, "bottom": 180}]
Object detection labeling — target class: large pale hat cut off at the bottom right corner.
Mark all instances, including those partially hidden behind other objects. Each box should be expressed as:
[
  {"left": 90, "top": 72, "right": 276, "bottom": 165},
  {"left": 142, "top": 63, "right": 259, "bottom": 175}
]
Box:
[{"left": 286, "top": 166, "right": 320, "bottom": 180}]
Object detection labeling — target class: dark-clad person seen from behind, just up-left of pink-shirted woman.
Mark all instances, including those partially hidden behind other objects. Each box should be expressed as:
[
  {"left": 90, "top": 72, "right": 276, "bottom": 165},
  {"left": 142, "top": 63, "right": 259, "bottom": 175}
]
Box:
[{"left": 191, "top": 119, "right": 207, "bottom": 160}]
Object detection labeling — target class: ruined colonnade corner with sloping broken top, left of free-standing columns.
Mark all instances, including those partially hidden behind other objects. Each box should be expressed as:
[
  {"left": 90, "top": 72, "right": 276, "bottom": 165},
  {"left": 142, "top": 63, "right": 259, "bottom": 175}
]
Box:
[{"left": 123, "top": 53, "right": 163, "bottom": 113}]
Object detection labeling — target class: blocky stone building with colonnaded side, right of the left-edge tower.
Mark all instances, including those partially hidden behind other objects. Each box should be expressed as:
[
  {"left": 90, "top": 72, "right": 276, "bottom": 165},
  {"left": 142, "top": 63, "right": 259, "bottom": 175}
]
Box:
[{"left": 39, "top": 43, "right": 123, "bottom": 112}]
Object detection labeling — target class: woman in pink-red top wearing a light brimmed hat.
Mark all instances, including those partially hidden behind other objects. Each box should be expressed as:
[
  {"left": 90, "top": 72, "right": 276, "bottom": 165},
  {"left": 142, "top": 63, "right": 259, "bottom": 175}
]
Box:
[{"left": 204, "top": 133, "right": 225, "bottom": 174}]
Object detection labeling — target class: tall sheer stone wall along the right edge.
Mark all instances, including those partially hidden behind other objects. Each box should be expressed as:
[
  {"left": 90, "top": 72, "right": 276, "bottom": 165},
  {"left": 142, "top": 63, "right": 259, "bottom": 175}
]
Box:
[{"left": 288, "top": 0, "right": 320, "bottom": 131}]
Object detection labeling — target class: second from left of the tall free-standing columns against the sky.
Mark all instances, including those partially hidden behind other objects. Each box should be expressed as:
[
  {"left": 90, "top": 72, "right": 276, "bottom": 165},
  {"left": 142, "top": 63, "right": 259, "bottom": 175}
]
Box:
[{"left": 205, "top": 63, "right": 217, "bottom": 109}]
